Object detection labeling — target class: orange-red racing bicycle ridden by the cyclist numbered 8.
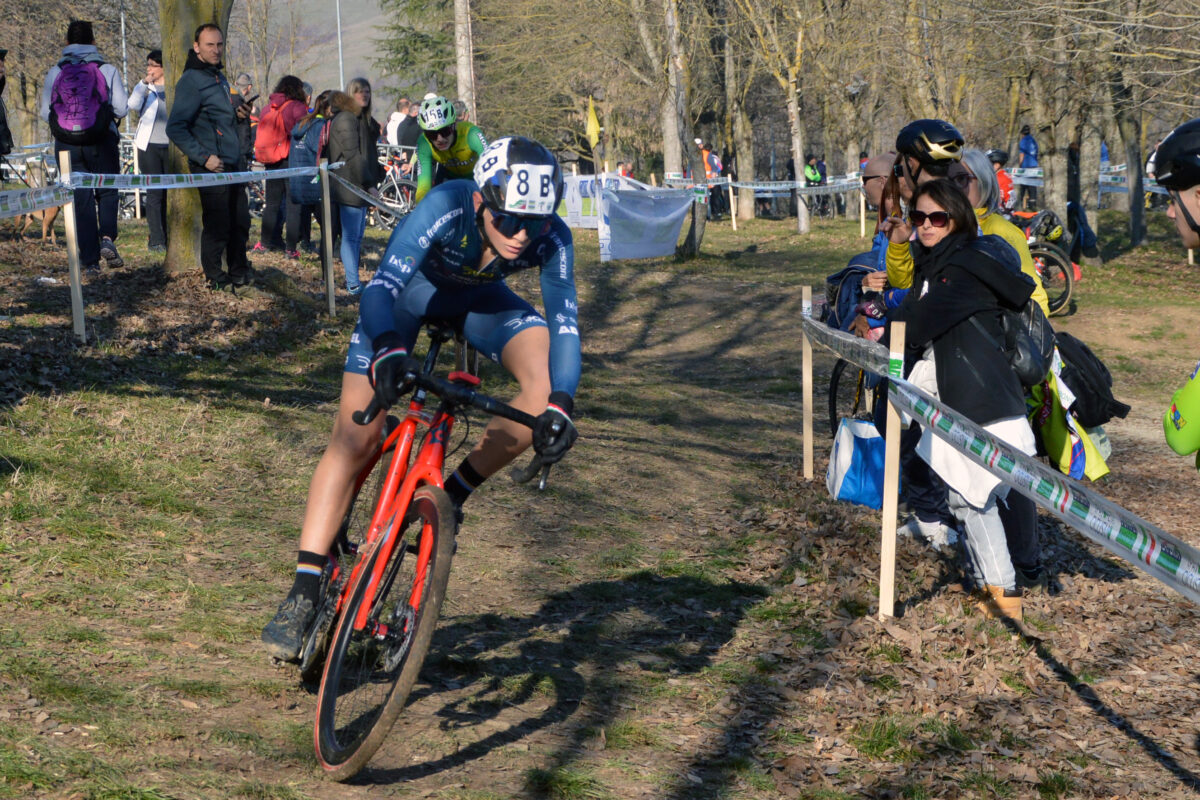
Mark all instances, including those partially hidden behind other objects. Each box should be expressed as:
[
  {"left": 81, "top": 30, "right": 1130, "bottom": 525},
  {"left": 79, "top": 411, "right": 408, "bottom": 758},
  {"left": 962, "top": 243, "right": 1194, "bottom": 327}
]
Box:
[{"left": 300, "top": 320, "right": 550, "bottom": 781}]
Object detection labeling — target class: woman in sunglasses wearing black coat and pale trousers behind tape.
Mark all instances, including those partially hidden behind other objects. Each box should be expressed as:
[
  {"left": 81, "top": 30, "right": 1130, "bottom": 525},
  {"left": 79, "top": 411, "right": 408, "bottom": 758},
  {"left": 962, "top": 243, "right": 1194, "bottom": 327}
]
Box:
[{"left": 889, "top": 179, "right": 1036, "bottom": 619}]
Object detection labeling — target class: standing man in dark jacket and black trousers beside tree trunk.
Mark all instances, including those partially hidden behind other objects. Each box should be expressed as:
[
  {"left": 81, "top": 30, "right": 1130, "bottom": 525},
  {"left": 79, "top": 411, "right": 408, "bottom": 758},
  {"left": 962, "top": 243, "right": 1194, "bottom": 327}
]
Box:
[{"left": 167, "top": 23, "right": 251, "bottom": 291}]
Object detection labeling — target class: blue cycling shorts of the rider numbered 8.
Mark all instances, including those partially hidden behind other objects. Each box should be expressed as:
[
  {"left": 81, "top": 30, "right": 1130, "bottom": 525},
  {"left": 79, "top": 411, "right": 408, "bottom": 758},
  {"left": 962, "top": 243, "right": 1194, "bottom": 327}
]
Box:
[{"left": 343, "top": 272, "right": 547, "bottom": 375}]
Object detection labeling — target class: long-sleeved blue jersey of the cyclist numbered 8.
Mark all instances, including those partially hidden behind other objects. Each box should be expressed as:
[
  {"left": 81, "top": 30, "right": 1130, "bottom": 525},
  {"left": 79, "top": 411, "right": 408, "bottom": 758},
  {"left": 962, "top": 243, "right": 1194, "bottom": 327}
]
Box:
[{"left": 359, "top": 180, "right": 581, "bottom": 396}]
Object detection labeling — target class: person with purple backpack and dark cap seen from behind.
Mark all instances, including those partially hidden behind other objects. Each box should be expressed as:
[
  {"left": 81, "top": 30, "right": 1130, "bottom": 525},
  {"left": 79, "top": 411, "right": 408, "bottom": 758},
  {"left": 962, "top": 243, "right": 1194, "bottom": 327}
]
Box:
[{"left": 41, "top": 19, "right": 128, "bottom": 272}]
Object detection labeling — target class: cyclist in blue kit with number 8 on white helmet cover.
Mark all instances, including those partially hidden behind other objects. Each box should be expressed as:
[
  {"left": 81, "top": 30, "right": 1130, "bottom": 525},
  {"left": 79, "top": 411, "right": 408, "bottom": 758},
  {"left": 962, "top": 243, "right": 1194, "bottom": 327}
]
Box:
[{"left": 263, "top": 137, "right": 581, "bottom": 661}]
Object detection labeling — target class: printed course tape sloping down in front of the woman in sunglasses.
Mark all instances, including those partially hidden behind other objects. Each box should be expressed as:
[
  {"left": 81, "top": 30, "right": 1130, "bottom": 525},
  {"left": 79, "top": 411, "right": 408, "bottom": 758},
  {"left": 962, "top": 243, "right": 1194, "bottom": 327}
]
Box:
[{"left": 800, "top": 317, "right": 1200, "bottom": 604}]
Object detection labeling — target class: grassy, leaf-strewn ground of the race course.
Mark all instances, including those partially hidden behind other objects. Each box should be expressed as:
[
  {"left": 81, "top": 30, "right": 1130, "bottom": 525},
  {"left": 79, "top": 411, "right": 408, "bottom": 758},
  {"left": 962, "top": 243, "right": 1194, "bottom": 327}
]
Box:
[{"left": 0, "top": 212, "right": 1200, "bottom": 800}]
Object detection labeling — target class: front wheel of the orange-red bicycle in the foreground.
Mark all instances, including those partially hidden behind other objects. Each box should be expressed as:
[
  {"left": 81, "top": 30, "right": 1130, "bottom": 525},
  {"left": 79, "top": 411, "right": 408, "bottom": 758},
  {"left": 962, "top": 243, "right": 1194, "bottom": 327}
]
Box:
[{"left": 314, "top": 486, "right": 455, "bottom": 781}]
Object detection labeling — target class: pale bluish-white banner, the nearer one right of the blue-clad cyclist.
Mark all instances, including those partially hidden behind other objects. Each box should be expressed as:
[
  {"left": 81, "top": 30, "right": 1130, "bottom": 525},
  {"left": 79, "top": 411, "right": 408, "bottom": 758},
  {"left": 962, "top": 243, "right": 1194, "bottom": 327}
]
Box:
[{"left": 598, "top": 182, "right": 695, "bottom": 261}]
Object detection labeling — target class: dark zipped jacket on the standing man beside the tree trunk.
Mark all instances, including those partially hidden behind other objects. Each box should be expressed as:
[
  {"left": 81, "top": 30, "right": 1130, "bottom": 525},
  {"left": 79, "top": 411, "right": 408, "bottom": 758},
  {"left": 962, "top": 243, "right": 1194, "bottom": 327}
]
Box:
[{"left": 167, "top": 50, "right": 246, "bottom": 172}]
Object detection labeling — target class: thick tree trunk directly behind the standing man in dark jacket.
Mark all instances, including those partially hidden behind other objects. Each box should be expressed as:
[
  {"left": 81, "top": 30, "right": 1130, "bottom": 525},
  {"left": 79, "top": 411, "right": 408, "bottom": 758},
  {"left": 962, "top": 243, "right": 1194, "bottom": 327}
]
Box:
[{"left": 158, "top": 0, "right": 233, "bottom": 275}]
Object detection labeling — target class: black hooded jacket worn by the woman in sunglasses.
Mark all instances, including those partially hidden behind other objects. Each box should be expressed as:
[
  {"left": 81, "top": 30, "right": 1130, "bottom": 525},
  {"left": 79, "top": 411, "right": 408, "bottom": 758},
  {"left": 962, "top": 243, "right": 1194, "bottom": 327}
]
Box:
[{"left": 888, "top": 234, "right": 1033, "bottom": 425}]
